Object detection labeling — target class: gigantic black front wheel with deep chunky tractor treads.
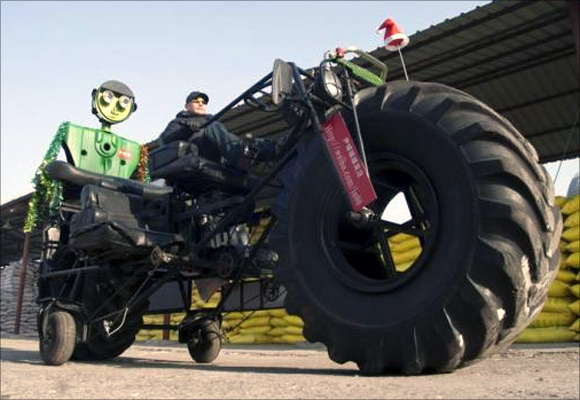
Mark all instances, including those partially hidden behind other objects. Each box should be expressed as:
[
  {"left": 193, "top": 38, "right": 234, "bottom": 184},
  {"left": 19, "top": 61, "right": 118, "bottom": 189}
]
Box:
[{"left": 270, "top": 81, "right": 562, "bottom": 375}]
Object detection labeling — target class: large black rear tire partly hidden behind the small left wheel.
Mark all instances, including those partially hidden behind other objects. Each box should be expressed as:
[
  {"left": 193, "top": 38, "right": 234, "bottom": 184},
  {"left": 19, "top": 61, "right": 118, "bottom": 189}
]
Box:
[{"left": 72, "top": 270, "right": 149, "bottom": 361}]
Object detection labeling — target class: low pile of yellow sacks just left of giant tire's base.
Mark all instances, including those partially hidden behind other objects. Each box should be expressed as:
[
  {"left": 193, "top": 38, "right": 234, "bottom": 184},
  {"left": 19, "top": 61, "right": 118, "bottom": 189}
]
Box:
[{"left": 222, "top": 308, "right": 306, "bottom": 344}]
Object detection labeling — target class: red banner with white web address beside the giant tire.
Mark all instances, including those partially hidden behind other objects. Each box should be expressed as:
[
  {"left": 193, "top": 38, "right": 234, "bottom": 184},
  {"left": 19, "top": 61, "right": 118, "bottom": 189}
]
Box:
[{"left": 322, "top": 112, "right": 377, "bottom": 211}]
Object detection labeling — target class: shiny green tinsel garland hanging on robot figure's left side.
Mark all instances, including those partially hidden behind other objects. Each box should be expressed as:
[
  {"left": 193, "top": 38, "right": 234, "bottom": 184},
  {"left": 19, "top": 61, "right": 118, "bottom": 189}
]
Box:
[{"left": 23, "top": 122, "right": 69, "bottom": 232}]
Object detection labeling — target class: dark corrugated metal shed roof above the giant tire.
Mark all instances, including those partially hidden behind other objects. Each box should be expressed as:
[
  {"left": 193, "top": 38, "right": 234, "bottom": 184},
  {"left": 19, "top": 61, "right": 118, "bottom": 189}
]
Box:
[{"left": 224, "top": 0, "right": 580, "bottom": 162}]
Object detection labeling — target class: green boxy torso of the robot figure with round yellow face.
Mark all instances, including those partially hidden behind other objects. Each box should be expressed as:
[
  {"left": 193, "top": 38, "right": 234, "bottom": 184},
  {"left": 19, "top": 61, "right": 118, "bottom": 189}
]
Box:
[{"left": 62, "top": 122, "right": 141, "bottom": 178}]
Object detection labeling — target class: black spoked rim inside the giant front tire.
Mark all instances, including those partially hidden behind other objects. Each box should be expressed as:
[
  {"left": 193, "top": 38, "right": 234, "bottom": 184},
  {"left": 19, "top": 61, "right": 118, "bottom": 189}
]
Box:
[{"left": 322, "top": 153, "right": 439, "bottom": 292}]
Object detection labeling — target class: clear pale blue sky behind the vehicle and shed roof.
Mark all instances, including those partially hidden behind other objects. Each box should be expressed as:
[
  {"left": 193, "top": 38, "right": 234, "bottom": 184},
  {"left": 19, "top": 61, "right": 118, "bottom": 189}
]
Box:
[{"left": 0, "top": 1, "right": 578, "bottom": 203}]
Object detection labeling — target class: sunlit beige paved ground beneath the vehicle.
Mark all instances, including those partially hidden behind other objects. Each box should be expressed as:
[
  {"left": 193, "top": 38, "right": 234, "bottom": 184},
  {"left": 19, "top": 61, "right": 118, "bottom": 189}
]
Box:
[{"left": 0, "top": 336, "right": 580, "bottom": 399}]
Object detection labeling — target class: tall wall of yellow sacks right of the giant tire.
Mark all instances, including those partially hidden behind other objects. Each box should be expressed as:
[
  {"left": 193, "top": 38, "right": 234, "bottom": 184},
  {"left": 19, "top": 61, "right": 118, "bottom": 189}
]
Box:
[{"left": 516, "top": 195, "right": 580, "bottom": 343}]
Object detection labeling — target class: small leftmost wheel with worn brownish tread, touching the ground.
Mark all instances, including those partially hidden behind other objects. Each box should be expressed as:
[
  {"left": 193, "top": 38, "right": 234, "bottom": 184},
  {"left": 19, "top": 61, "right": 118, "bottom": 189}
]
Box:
[{"left": 40, "top": 310, "right": 77, "bottom": 365}]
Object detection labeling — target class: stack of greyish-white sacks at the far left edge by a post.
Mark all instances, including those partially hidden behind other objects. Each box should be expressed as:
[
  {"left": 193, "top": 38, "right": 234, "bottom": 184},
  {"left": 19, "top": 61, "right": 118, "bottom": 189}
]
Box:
[{"left": 0, "top": 260, "right": 40, "bottom": 334}]
